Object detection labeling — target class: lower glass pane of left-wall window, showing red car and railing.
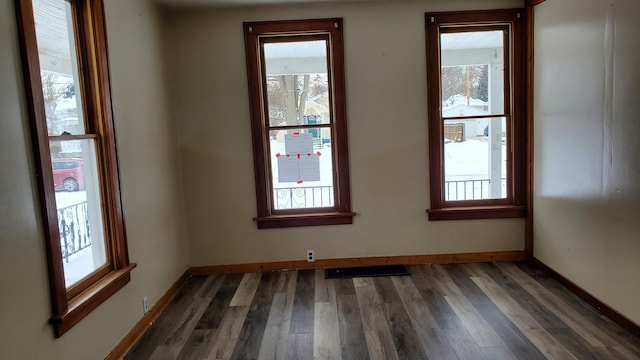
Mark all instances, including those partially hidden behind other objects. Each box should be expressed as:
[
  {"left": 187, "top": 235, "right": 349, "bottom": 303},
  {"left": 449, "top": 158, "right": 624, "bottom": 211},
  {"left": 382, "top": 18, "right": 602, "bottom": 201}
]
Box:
[{"left": 50, "top": 140, "right": 107, "bottom": 288}]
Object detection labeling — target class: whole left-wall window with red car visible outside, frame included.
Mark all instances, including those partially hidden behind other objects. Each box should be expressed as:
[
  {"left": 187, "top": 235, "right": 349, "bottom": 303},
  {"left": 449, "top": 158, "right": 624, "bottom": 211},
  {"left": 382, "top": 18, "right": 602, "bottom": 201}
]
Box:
[{"left": 17, "top": 0, "right": 135, "bottom": 337}]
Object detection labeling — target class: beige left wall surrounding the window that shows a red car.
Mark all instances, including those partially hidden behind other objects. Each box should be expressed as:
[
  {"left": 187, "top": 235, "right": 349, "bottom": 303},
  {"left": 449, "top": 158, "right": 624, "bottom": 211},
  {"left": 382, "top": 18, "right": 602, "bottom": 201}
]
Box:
[{"left": 0, "top": 0, "right": 187, "bottom": 360}]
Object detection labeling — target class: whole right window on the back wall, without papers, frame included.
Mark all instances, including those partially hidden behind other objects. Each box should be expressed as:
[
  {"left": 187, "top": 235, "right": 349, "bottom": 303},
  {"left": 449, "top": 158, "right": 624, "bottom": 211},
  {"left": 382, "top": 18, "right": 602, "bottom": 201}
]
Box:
[{"left": 426, "top": 9, "right": 526, "bottom": 220}]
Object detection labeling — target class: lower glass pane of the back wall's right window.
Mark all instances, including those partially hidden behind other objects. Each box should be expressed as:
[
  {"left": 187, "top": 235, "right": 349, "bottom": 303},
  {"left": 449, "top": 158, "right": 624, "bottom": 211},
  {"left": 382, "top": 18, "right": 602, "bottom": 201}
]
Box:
[{"left": 444, "top": 117, "right": 507, "bottom": 201}]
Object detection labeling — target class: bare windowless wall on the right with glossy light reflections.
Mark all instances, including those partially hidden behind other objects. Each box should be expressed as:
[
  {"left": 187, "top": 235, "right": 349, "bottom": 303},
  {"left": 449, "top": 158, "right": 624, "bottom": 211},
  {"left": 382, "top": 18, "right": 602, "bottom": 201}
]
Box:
[{"left": 534, "top": 0, "right": 640, "bottom": 324}]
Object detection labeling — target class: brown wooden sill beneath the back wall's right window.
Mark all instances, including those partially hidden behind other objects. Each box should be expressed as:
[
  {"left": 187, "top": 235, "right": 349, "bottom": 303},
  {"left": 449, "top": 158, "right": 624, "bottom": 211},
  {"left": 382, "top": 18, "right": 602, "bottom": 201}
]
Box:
[{"left": 427, "top": 205, "right": 527, "bottom": 221}]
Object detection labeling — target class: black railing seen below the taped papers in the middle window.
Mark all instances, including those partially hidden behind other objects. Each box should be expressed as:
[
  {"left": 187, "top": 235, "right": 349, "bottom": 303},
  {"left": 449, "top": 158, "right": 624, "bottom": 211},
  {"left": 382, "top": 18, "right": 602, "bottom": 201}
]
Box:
[{"left": 273, "top": 186, "right": 333, "bottom": 210}]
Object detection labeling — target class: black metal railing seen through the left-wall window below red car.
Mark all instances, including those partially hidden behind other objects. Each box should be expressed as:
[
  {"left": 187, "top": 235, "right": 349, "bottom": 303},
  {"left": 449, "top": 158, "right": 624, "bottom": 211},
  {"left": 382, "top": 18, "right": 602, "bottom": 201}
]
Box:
[{"left": 58, "top": 201, "right": 91, "bottom": 262}]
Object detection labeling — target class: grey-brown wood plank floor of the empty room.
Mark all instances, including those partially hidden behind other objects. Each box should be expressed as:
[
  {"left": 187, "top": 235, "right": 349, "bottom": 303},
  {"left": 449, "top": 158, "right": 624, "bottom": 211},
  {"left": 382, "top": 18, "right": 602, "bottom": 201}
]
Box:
[{"left": 125, "top": 262, "right": 640, "bottom": 360}]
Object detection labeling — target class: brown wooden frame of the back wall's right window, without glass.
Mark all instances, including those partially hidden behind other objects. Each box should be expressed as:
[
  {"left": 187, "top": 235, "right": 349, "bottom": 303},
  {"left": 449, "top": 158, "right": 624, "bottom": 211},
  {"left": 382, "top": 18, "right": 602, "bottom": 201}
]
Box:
[{"left": 425, "top": 9, "right": 528, "bottom": 220}]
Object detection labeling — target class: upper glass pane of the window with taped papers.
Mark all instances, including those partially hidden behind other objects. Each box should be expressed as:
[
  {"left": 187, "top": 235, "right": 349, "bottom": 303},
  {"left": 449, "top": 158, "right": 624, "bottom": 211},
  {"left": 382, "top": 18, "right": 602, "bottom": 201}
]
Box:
[{"left": 264, "top": 40, "right": 331, "bottom": 126}]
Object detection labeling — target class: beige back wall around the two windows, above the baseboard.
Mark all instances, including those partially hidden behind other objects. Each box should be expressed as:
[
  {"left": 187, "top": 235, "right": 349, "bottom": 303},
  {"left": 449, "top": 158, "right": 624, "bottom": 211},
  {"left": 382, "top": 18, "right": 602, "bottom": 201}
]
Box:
[{"left": 164, "top": 0, "right": 524, "bottom": 266}]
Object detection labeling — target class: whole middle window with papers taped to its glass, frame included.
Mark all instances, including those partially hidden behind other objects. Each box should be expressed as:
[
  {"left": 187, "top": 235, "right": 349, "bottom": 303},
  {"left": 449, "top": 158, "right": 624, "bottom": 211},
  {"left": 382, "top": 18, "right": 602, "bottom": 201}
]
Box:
[{"left": 244, "top": 19, "right": 355, "bottom": 229}]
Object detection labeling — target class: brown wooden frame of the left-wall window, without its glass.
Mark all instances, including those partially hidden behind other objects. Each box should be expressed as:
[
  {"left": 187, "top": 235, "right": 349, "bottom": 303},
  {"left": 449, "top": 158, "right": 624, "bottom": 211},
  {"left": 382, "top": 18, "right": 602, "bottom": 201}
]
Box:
[{"left": 16, "top": 0, "right": 136, "bottom": 337}]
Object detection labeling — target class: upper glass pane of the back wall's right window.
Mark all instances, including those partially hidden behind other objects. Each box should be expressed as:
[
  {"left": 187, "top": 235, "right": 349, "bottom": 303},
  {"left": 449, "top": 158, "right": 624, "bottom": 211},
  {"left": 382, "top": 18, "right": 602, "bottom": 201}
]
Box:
[{"left": 440, "top": 31, "right": 505, "bottom": 118}]
